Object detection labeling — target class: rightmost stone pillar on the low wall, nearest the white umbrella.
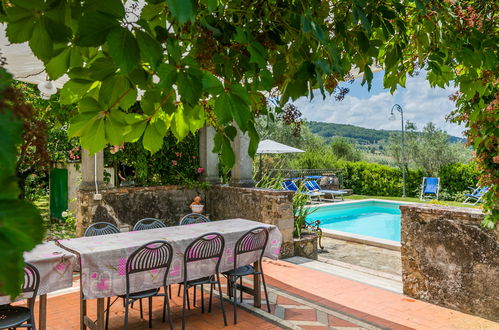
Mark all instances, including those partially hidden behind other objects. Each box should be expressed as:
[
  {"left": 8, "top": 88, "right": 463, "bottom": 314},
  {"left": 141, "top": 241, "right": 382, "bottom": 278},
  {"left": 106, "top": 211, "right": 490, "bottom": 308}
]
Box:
[{"left": 229, "top": 129, "right": 255, "bottom": 187}]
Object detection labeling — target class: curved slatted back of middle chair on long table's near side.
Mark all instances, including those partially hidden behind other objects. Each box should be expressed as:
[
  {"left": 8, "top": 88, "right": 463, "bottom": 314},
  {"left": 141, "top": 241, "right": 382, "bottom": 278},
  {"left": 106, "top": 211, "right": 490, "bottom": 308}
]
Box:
[{"left": 184, "top": 233, "right": 225, "bottom": 281}]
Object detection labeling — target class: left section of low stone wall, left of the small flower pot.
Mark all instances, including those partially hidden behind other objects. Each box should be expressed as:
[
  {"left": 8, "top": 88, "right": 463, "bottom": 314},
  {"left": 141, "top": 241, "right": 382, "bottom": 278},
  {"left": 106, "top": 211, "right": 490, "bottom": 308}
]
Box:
[{"left": 77, "top": 186, "right": 206, "bottom": 236}]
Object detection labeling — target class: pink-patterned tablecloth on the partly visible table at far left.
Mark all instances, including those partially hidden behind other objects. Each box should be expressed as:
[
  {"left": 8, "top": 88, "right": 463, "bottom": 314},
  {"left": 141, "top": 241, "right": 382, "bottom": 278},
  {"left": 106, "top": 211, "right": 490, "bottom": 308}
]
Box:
[{"left": 0, "top": 241, "right": 76, "bottom": 305}]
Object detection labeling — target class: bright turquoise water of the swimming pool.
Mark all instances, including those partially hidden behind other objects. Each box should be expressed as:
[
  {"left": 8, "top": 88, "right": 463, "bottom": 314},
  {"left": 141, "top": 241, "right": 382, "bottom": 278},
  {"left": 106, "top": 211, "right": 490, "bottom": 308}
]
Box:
[{"left": 307, "top": 201, "right": 401, "bottom": 242}]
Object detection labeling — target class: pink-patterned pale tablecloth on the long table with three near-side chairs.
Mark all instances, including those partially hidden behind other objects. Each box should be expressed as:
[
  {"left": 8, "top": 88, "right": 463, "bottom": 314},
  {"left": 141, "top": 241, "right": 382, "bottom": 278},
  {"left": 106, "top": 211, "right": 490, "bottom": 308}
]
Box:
[{"left": 58, "top": 219, "right": 282, "bottom": 299}]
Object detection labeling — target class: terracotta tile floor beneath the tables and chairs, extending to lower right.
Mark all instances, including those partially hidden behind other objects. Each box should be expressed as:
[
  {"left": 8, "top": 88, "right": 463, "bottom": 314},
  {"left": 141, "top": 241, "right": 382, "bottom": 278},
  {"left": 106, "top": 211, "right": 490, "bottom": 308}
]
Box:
[{"left": 22, "top": 261, "right": 499, "bottom": 330}]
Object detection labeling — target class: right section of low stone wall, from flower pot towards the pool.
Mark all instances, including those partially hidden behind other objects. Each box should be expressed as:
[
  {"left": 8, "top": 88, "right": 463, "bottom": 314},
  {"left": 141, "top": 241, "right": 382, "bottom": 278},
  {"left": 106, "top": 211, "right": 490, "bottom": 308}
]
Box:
[{"left": 206, "top": 185, "right": 294, "bottom": 257}]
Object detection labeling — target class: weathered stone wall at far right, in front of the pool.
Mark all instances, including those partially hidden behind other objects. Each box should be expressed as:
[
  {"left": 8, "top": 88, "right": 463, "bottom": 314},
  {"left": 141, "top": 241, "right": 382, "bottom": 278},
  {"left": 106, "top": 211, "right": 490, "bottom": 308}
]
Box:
[{"left": 400, "top": 204, "right": 499, "bottom": 321}]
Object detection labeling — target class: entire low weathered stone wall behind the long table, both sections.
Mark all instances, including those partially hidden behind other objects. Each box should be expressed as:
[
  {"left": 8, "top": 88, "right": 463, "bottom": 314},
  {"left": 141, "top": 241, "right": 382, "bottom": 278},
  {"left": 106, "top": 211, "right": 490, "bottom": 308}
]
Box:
[{"left": 76, "top": 185, "right": 294, "bottom": 257}]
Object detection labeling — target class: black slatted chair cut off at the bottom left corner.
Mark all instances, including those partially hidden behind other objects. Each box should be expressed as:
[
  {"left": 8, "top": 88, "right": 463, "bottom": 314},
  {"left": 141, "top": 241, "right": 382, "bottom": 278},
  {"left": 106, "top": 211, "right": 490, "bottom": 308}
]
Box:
[{"left": 0, "top": 263, "right": 40, "bottom": 330}]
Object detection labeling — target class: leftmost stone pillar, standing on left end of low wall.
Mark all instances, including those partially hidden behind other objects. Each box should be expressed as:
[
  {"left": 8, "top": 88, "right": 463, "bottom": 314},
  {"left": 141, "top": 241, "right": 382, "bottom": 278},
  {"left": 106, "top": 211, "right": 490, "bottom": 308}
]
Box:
[{"left": 78, "top": 149, "right": 105, "bottom": 190}]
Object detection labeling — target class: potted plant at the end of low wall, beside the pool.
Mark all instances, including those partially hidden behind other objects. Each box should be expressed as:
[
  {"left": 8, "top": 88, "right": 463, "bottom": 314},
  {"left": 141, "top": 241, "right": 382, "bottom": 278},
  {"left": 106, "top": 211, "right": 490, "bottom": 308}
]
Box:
[{"left": 293, "top": 191, "right": 322, "bottom": 259}]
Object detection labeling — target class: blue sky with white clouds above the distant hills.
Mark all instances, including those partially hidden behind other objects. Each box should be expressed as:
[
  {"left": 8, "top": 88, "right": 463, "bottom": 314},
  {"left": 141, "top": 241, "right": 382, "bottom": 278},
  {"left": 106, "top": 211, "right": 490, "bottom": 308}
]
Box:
[{"left": 294, "top": 72, "right": 464, "bottom": 137}]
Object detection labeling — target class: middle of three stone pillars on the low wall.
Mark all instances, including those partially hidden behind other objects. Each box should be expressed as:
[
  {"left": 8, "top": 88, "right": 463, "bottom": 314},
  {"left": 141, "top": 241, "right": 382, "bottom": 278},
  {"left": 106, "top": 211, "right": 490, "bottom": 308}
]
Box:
[{"left": 199, "top": 124, "right": 220, "bottom": 184}]
